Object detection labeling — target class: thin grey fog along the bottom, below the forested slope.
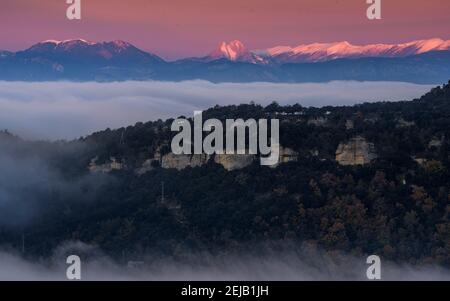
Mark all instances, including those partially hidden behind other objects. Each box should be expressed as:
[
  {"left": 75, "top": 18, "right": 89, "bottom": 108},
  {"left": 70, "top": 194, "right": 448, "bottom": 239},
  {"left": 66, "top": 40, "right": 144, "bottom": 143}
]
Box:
[{"left": 0, "top": 242, "right": 450, "bottom": 281}]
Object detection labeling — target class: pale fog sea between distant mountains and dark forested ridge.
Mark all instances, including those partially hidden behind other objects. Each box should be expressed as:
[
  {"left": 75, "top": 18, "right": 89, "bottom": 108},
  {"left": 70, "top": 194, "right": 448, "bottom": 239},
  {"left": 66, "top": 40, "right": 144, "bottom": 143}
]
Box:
[{"left": 0, "top": 81, "right": 433, "bottom": 139}]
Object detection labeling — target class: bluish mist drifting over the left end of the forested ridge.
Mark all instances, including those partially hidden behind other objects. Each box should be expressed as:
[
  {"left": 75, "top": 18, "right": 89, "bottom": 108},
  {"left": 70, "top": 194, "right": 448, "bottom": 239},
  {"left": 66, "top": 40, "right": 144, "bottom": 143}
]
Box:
[{"left": 0, "top": 133, "right": 111, "bottom": 227}]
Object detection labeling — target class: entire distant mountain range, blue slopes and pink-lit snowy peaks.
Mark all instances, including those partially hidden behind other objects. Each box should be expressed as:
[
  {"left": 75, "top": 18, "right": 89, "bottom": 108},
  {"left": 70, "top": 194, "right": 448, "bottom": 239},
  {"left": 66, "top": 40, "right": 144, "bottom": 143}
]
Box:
[{"left": 0, "top": 39, "right": 450, "bottom": 84}]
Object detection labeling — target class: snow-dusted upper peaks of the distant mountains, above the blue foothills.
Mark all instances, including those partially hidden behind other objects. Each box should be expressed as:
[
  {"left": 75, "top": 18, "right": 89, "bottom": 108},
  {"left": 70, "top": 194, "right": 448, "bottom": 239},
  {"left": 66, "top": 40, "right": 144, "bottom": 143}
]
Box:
[{"left": 9, "top": 38, "right": 450, "bottom": 64}]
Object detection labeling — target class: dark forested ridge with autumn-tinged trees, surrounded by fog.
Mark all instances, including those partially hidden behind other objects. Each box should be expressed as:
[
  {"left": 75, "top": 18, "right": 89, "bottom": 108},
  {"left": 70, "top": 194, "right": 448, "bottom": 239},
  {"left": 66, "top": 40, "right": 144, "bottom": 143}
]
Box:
[{"left": 0, "top": 80, "right": 450, "bottom": 266}]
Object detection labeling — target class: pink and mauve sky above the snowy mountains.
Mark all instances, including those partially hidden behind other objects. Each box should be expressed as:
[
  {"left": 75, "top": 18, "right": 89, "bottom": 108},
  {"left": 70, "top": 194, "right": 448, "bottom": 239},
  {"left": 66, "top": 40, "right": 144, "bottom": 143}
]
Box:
[{"left": 0, "top": 0, "right": 450, "bottom": 59}]
